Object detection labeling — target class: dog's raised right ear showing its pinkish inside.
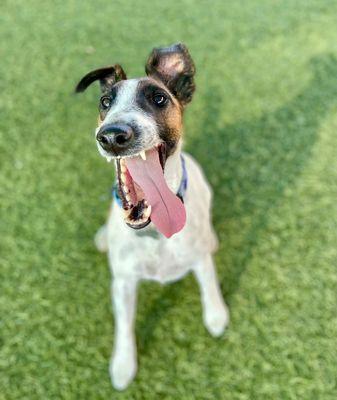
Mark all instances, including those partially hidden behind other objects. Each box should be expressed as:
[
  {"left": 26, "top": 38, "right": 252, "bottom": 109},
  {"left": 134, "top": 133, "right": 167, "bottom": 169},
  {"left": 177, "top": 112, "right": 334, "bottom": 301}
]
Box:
[{"left": 145, "top": 43, "right": 195, "bottom": 105}]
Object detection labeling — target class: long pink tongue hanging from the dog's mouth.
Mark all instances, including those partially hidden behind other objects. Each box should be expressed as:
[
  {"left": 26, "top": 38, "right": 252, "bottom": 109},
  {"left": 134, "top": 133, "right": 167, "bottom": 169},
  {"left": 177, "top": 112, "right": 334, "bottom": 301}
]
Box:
[{"left": 126, "top": 149, "right": 186, "bottom": 238}]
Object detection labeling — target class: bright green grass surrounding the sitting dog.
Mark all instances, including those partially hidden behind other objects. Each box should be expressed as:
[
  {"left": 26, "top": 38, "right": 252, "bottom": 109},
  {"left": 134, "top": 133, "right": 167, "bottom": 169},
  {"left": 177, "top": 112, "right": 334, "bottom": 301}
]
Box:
[{"left": 0, "top": 0, "right": 337, "bottom": 400}]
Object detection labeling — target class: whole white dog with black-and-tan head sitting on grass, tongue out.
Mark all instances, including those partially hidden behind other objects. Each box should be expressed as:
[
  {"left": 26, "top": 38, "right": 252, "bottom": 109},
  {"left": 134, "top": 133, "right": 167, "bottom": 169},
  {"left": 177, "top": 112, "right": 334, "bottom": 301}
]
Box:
[{"left": 75, "top": 43, "right": 229, "bottom": 390}]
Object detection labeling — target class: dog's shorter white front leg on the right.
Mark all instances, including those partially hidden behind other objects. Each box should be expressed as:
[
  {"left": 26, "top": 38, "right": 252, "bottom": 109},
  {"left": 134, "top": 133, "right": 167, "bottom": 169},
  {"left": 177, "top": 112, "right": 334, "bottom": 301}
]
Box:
[{"left": 194, "top": 254, "right": 229, "bottom": 336}]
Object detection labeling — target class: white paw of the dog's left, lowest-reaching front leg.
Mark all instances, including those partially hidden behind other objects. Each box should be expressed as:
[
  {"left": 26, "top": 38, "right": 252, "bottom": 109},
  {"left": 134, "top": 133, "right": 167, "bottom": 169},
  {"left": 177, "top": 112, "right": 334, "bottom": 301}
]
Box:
[{"left": 110, "top": 352, "right": 137, "bottom": 390}]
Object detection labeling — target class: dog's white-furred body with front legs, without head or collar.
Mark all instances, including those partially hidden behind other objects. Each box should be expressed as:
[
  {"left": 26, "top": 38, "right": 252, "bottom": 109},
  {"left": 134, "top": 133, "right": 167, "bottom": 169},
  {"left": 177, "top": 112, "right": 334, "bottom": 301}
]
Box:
[{"left": 96, "top": 140, "right": 228, "bottom": 390}]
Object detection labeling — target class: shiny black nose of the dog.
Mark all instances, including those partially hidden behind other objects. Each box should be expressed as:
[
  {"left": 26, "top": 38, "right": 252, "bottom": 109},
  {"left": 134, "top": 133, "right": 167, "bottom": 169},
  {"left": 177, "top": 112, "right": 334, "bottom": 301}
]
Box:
[{"left": 96, "top": 124, "right": 134, "bottom": 154}]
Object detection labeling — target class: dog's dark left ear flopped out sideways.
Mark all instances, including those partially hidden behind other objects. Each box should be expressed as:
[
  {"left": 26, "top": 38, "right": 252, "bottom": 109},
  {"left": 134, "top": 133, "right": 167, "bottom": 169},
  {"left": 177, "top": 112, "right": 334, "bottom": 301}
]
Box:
[{"left": 75, "top": 64, "right": 126, "bottom": 93}]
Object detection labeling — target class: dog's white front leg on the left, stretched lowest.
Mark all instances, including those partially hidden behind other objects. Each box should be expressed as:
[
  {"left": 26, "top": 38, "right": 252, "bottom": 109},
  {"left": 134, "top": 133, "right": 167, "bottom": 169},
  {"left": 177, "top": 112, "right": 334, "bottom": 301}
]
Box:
[{"left": 110, "top": 277, "right": 137, "bottom": 390}]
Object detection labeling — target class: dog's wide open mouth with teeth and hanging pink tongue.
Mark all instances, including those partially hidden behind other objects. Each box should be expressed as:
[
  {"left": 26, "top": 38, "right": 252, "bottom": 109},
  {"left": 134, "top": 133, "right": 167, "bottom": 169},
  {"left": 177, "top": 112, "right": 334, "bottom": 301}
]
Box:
[{"left": 116, "top": 144, "right": 186, "bottom": 237}]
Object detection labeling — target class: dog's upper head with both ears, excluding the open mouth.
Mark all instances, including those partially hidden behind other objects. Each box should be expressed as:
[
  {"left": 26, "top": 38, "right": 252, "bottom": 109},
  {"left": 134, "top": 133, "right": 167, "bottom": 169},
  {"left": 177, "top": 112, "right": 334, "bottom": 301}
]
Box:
[{"left": 76, "top": 44, "right": 195, "bottom": 158}]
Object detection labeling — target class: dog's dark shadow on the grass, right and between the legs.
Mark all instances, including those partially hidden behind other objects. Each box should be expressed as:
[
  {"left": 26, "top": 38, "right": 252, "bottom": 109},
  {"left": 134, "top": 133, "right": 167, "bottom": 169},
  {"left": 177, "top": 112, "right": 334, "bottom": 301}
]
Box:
[{"left": 137, "top": 55, "right": 337, "bottom": 352}]
